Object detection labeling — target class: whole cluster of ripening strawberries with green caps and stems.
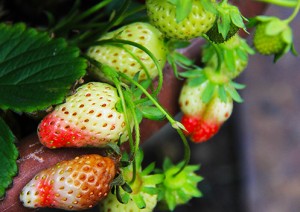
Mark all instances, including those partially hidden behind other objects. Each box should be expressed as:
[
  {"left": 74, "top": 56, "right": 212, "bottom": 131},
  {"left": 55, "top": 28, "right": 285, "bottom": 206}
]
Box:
[{"left": 14, "top": 0, "right": 300, "bottom": 211}]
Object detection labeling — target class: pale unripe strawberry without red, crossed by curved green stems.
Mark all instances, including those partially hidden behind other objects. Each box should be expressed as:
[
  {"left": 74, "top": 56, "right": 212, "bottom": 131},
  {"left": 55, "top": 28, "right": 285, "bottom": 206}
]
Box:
[{"left": 87, "top": 22, "right": 167, "bottom": 80}]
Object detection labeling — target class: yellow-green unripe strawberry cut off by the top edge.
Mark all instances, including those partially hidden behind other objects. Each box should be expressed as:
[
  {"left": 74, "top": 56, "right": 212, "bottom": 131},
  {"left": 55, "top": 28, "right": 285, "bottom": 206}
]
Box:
[{"left": 146, "top": 0, "right": 216, "bottom": 40}]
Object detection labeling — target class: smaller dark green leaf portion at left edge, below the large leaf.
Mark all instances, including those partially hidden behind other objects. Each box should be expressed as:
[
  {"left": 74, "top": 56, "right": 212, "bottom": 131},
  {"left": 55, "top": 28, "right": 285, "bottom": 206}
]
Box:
[{"left": 0, "top": 118, "right": 19, "bottom": 198}]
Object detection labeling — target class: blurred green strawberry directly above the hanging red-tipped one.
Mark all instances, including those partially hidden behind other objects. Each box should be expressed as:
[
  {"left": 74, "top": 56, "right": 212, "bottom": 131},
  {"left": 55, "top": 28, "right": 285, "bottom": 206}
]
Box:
[{"left": 202, "top": 35, "right": 254, "bottom": 79}]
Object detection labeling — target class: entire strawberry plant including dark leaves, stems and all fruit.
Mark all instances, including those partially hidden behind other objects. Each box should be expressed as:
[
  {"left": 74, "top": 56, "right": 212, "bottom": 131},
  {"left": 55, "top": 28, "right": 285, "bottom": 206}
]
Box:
[{"left": 0, "top": 0, "right": 300, "bottom": 211}]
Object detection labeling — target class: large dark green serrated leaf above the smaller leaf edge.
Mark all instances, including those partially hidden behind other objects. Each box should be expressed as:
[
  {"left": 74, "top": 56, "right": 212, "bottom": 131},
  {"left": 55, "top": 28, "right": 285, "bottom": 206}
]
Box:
[{"left": 0, "top": 24, "right": 86, "bottom": 112}]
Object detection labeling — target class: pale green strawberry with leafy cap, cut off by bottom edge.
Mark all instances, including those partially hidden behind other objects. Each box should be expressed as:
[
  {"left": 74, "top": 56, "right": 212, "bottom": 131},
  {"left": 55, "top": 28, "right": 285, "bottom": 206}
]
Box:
[{"left": 99, "top": 150, "right": 164, "bottom": 212}]
